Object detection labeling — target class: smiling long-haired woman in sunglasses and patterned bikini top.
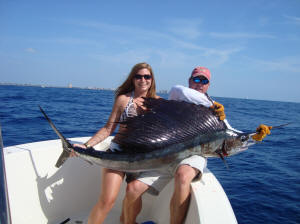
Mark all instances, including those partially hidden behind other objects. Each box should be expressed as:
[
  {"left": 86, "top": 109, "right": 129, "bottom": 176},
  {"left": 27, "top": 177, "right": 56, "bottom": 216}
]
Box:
[{"left": 77, "top": 63, "right": 159, "bottom": 224}]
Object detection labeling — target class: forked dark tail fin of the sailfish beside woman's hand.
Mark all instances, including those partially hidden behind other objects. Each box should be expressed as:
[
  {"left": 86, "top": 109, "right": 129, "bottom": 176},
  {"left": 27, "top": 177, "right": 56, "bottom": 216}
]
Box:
[{"left": 39, "top": 106, "right": 73, "bottom": 168}]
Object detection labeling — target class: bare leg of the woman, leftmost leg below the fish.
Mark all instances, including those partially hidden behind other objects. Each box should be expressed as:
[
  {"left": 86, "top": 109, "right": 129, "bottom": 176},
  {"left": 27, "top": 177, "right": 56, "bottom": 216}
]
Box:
[{"left": 88, "top": 168, "right": 124, "bottom": 224}]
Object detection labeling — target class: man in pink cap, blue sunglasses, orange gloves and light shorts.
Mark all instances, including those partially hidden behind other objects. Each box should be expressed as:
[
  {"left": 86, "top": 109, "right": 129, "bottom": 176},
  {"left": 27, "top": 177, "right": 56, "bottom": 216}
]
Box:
[{"left": 121, "top": 67, "right": 270, "bottom": 224}]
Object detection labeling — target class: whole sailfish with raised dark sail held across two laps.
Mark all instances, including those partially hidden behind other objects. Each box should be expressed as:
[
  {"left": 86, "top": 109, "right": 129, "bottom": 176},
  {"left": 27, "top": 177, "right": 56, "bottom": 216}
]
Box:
[{"left": 40, "top": 98, "right": 284, "bottom": 172}]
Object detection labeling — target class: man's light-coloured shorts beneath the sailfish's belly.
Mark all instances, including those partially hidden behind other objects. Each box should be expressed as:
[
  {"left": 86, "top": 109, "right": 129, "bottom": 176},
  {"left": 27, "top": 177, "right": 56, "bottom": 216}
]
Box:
[{"left": 130, "top": 155, "right": 207, "bottom": 195}]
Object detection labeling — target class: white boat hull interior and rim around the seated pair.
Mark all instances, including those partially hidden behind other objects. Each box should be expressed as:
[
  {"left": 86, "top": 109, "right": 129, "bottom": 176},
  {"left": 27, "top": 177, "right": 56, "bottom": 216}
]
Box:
[{"left": 4, "top": 137, "right": 237, "bottom": 224}]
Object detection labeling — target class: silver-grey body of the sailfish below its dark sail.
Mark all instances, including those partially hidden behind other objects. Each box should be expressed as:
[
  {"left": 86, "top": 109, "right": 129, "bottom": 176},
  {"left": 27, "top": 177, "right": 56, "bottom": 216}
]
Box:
[{"left": 75, "top": 132, "right": 226, "bottom": 172}]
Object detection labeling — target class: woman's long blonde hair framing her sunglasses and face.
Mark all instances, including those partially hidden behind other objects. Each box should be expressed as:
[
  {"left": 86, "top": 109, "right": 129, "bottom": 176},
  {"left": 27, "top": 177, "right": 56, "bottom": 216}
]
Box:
[{"left": 115, "top": 62, "right": 156, "bottom": 98}]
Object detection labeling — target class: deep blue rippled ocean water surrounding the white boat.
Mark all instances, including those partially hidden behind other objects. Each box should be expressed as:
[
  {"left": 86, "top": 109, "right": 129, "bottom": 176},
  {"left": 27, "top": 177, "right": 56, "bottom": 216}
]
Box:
[{"left": 0, "top": 85, "right": 300, "bottom": 224}]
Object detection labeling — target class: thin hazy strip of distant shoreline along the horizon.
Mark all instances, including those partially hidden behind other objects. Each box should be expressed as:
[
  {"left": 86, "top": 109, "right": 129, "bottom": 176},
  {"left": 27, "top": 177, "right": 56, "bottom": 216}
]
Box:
[{"left": 0, "top": 83, "right": 168, "bottom": 93}]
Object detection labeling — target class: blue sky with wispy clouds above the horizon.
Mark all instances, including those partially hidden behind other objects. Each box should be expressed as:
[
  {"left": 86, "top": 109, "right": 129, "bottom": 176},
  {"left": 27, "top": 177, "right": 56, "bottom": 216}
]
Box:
[{"left": 0, "top": 0, "right": 300, "bottom": 102}]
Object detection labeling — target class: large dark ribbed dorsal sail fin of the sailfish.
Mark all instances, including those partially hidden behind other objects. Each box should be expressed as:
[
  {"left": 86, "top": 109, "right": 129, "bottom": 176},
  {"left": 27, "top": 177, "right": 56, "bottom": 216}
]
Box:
[{"left": 114, "top": 98, "right": 226, "bottom": 153}]
